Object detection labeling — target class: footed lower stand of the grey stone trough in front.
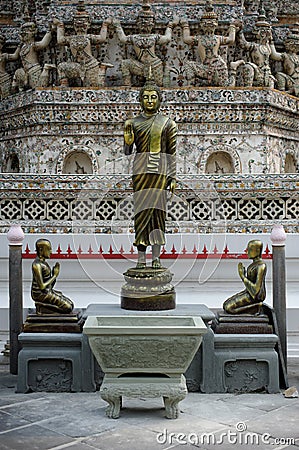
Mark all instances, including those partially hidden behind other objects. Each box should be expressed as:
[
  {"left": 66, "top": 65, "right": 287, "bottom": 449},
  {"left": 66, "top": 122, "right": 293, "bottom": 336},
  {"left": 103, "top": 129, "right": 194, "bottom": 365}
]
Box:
[{"left": 100, "top": 375, "right": 187, "bottom": 419}]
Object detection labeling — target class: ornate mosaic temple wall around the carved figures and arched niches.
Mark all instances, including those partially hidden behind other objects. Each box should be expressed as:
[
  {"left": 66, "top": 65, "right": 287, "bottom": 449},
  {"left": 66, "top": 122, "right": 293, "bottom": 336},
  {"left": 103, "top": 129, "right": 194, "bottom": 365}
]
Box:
[{"left": 0, "top": 0, "right": 299, "bottom": 175}]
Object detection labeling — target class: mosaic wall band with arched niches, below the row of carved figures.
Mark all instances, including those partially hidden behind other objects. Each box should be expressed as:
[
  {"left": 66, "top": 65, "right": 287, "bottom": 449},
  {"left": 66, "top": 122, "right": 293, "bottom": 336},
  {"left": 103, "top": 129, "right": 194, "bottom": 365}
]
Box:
[{"left": 0, "top": 88, "right": 299, "bottom": 175}]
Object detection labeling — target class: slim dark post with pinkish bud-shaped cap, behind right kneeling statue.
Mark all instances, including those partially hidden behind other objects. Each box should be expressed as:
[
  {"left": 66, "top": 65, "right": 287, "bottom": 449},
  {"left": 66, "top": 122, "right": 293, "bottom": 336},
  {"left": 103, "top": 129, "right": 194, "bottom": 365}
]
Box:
[{"left": 270, "top": 225, "right": 287, "bottom": 367}]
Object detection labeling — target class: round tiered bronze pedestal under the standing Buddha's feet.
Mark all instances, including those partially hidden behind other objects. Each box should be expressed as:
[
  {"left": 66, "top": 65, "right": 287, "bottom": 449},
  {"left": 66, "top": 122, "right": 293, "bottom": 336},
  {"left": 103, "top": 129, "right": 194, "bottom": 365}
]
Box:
[{"left": 121, "top": 267, "right": 176, "bottom": 311}]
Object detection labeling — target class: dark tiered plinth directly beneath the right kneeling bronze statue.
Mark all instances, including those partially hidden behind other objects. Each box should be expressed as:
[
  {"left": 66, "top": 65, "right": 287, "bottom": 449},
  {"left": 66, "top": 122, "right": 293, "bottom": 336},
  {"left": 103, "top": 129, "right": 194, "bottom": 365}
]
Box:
[{"left": 212, "top": 311, "right": 273, "bottom": 334}]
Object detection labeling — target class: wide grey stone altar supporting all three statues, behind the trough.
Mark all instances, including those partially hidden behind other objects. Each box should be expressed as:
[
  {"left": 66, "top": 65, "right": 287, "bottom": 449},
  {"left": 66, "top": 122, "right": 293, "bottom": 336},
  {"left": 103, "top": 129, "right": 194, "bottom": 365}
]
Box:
[{"left": 17, "top": 304, "right": 279, "bottom": 393}]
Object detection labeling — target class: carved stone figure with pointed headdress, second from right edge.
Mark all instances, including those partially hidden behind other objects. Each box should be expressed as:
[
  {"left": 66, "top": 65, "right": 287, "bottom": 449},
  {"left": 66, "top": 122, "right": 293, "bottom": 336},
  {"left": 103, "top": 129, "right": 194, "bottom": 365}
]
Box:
[{"left": 237, "top": 9, "right": 280, "bottom": 88}]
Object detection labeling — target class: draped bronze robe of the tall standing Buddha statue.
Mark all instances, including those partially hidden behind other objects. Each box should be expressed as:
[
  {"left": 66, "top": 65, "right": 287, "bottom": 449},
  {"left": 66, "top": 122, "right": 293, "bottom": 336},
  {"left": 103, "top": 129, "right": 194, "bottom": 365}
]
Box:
[{"left": 125, "top": 114, "right": 177, "bottom": 247}]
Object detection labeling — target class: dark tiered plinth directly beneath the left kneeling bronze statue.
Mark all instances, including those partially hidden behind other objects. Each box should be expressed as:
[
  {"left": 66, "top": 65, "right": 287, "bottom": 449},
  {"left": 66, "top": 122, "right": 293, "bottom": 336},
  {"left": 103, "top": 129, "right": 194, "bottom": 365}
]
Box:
[{"left": 23, "top": 311, "right": 84, "bottom": 333}]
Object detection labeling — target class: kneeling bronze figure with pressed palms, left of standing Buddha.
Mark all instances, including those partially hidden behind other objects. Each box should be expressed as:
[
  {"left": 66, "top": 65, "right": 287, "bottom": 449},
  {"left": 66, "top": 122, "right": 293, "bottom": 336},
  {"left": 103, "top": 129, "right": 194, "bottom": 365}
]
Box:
[{"left": 31, "top": 239, "right": 74, "bottom": 314}]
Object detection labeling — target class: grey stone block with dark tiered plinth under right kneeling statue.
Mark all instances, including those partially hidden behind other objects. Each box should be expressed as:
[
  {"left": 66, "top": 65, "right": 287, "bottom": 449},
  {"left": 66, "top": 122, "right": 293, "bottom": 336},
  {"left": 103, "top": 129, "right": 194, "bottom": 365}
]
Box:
[{"left": 203, "top": 311, "right": 279, "bottom": 393}]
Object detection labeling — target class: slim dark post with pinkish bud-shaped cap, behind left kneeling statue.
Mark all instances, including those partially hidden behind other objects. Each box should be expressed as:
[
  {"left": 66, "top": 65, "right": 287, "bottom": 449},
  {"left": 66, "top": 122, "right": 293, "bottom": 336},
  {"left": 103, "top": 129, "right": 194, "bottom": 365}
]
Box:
[{"left": 7, "top": 225, "right": 24, "bottom": 375}]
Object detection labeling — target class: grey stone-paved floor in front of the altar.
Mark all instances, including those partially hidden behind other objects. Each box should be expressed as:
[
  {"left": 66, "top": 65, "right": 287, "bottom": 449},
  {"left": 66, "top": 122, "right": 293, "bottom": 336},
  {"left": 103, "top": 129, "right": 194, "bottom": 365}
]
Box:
[{"left": 0, "top": 357, "right": 299, "bottom": 450}]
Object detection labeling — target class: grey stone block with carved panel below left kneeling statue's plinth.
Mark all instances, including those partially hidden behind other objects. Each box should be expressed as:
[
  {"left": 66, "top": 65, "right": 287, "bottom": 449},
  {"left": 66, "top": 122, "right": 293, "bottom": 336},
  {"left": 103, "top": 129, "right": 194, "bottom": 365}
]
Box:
[{"left": 17, "top": 333, "right": 95, "bottom": 393}]
